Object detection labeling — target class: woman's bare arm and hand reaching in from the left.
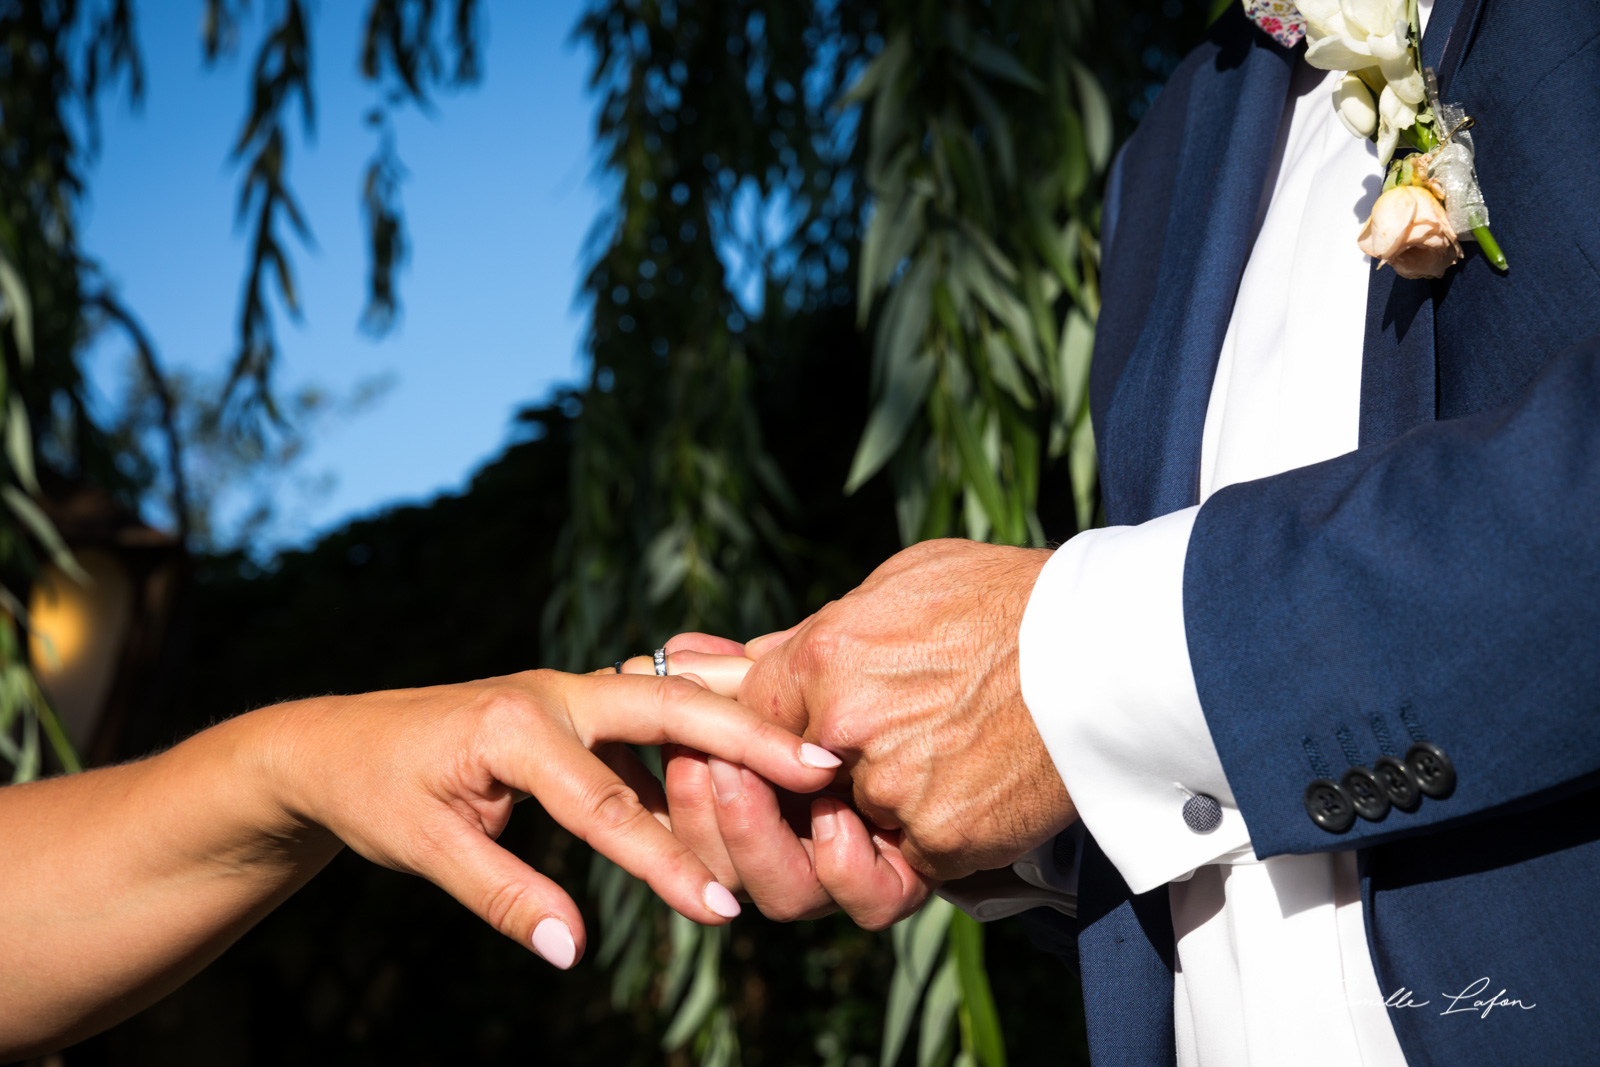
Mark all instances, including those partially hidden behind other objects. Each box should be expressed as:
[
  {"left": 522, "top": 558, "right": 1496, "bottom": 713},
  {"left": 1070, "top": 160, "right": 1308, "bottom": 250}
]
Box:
[{"left": 0, "top": 672, "right": 837, "bottom": 1061}]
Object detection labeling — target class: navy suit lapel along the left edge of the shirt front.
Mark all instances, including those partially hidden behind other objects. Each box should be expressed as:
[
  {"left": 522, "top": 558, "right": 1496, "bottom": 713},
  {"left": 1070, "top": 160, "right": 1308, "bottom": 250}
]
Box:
[{"left": 1102, "top": 6, "right": 1294, "bottom": 523}]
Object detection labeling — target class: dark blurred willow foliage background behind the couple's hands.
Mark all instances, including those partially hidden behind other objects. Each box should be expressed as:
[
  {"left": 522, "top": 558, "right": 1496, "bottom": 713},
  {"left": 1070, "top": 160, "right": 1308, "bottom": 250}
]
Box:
[{"left": 0, "top": 0, "right": 1210, "bottom": 1067}]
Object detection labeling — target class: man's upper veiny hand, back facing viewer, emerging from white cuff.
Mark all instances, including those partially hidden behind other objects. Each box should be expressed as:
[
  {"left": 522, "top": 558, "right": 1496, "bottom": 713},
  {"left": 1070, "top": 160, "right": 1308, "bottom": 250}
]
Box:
[{"left": 739, "top": 541, "right": 1077, "bottom": 878}]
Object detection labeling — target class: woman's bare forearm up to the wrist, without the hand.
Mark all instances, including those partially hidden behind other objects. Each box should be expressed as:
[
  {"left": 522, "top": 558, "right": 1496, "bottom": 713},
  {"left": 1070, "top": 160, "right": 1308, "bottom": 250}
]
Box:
[{"left": 0, "top": 705, "right": 339, "bottom": 1059}]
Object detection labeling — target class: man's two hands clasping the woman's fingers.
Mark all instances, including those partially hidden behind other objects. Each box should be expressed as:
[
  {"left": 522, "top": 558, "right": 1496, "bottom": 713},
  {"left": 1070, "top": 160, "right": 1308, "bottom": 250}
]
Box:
[{"left": 656, "top": 541, "right": 1075, "bottom": 928}]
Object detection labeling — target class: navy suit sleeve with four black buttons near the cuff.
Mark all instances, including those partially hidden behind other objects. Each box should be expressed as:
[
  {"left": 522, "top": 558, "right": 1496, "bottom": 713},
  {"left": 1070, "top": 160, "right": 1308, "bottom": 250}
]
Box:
[{"left": 1182, "top": 329, "right": 1600, "bottom": 857}]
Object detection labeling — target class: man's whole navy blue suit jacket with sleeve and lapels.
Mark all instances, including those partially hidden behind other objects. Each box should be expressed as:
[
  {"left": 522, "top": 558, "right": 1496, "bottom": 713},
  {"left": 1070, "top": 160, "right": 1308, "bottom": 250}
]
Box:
[{"left": 1036, "top": 0, "right": 1600, "bottom": 1067}]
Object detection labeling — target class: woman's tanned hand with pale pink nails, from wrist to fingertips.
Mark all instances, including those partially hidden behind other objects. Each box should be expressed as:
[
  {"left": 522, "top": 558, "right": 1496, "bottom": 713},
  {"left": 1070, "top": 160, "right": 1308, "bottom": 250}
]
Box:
[{"left": 272, "top": 670, "right": 838, "bottom": 968}]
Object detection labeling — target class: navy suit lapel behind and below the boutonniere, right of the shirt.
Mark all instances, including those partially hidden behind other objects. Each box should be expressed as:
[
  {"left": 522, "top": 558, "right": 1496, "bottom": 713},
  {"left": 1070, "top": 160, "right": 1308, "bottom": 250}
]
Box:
[{"left": 1360, "top": 0, "right": 1483, "bottom": 448}]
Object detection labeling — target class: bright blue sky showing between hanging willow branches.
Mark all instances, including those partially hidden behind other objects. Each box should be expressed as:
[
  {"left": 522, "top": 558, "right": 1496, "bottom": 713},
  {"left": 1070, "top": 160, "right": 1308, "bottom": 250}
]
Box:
[{"left": 83, "top": 0, "right": 602, "bottom": 544}]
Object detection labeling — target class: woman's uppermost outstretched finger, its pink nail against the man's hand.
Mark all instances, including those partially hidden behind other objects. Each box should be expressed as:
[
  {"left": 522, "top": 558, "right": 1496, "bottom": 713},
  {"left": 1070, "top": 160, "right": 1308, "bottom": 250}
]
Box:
[{"left": 552, "top": 673, "right": 840, "bottom": 793}]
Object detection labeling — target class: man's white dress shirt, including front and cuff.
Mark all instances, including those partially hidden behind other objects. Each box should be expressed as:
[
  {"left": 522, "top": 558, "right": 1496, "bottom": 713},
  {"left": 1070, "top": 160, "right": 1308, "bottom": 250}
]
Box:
[{"left": 1011, "top": 0, "right": 1432, "bottom": 1067}]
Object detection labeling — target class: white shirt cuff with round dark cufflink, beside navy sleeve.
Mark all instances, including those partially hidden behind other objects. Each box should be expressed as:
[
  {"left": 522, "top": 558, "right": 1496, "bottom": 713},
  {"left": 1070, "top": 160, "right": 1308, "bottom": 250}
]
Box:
[{"left": 1021, "top": 507, "right": 1250, "bottom": 893}]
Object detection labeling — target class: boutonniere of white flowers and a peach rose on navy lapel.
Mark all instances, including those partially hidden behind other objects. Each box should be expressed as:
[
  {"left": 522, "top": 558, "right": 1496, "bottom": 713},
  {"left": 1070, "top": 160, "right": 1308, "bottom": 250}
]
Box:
[{"left": 1245, "top": 0, "right": 1507, "bottom": 278}]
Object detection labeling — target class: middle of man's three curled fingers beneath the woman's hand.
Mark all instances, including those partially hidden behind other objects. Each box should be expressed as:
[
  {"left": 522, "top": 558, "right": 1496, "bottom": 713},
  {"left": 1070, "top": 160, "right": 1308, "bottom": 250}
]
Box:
[{"left": 707, "top": 757, "right": 835, "bottom": 923}]
